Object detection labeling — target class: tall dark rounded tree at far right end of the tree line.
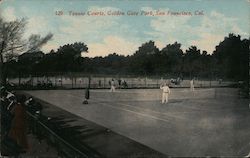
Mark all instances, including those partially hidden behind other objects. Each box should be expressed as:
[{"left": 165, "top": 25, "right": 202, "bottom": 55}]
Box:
[{"left": 213, "top": 33, "right": 249, "bottom": 80}]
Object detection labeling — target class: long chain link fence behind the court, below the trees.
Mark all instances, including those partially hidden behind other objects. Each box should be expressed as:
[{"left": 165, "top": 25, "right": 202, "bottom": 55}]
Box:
[{"left": 7, "top": 73, "right": 237, "bottom": 89}]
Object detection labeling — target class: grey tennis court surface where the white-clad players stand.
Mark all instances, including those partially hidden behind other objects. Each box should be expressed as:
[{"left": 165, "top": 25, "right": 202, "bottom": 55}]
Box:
[{"left": 24, "top": 88, "right": 250, "bottom": 156}]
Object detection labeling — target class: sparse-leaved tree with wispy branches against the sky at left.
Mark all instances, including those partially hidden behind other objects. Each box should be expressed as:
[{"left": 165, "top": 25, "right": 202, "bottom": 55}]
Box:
[{"left": 0, "top": 17, "right": 52, "bottom": 85}]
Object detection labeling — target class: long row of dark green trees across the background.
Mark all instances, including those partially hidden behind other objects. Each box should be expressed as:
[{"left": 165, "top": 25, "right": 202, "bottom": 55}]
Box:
[{"left": 5, "top": 33, "right": 249, "bottom": 80}]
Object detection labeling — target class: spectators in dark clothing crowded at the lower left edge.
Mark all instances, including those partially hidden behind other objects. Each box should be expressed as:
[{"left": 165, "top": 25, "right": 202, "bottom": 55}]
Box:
[{"left": 0, "top": 87, "right": 28, "bottom": 155}]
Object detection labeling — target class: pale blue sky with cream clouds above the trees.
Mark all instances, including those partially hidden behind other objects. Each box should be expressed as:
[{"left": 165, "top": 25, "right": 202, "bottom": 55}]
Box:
[{"left": 0, "top": 0, "right": 250, "bottom": 57}]
